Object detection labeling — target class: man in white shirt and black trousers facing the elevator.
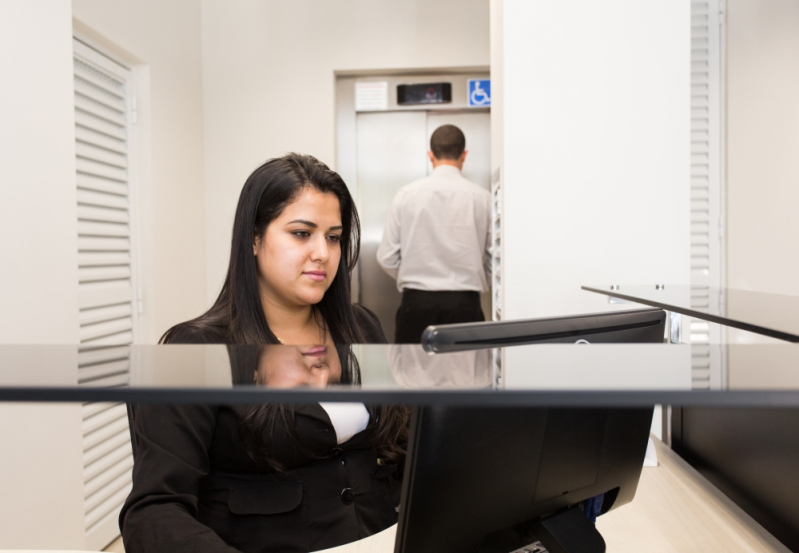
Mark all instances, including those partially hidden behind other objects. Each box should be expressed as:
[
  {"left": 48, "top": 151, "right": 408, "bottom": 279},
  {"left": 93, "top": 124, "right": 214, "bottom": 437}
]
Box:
[{"left": 377, "top": 125, "right": 491, "bottom": 344}]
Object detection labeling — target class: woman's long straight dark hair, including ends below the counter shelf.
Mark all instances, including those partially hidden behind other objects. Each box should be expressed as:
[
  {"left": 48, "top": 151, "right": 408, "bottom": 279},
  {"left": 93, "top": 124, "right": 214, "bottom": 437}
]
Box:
[{"left": 159, "top": 154, "right": 408, "bottom": 470}]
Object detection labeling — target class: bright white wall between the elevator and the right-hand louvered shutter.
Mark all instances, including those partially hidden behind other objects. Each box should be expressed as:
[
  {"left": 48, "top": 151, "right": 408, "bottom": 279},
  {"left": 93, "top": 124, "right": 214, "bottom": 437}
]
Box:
[{"left": 492, "top": 0, "right": 691, "bottom": 319}]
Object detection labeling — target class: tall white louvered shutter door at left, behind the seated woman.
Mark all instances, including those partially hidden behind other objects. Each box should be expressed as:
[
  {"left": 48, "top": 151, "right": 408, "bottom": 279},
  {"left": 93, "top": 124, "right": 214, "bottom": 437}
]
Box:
[{"left": 73, "top": 39, "right": 137, "bottom": 550}]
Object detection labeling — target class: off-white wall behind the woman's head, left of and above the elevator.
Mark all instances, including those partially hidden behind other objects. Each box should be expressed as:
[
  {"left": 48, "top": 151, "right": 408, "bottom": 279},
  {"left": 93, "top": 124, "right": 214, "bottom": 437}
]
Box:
[{"left": 202, "top": 0, "right": 489, "bottom": 304}]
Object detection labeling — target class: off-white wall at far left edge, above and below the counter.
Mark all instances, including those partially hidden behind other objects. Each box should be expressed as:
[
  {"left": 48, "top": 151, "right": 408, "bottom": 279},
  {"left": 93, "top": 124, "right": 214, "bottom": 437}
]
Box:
[{"left": 0, "top": 4, "right": 84, "bottom": 549}]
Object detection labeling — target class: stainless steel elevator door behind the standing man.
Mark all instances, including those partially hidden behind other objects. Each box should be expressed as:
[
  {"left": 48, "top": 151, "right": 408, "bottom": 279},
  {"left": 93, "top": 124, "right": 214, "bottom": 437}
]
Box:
[{"left": 356, "top": 111, "right": 491, "bottom": 341}]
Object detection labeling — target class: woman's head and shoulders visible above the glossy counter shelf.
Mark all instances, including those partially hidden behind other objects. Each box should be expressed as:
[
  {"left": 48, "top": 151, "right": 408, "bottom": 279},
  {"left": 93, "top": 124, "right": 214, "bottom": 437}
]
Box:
[{"left": 161, "top": 154, "right": 386, "bottom": 344}]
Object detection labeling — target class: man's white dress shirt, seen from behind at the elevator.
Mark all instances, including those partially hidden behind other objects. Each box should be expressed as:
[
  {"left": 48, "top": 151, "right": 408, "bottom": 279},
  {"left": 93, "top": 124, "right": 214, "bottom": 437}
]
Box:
[{"left": 377, "top": 165, "right": 491, "bottom": 292}]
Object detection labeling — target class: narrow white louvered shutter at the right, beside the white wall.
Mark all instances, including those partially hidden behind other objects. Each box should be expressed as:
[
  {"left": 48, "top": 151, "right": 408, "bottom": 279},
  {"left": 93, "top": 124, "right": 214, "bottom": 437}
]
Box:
[{"left": 690, "top": 0, "right": 724, "bottom": 388}]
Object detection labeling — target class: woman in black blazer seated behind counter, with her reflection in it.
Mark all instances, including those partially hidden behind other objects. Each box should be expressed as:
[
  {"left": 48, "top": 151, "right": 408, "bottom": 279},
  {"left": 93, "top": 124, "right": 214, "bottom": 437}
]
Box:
[{"left": 120, "top": 154, "right": 407, "bottom": 553}]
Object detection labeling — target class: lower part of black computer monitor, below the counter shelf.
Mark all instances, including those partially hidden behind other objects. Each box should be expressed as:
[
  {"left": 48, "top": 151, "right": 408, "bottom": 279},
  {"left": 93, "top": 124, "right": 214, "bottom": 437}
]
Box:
[{"left": 395, "top": 406, "right": 653, "bottom": 553}]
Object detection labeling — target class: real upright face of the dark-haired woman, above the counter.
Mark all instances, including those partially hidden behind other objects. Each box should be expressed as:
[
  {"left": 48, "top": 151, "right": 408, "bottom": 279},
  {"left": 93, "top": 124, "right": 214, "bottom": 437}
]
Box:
[{"left": 253, "top": 187, "right": 342, "bottom": 308}]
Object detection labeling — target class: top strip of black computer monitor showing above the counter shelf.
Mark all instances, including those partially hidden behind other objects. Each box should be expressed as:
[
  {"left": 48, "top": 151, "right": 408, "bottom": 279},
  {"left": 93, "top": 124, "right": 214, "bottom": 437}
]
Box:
[{"left": 422, "top": 309, "right": 666, "bottom": 353}]
